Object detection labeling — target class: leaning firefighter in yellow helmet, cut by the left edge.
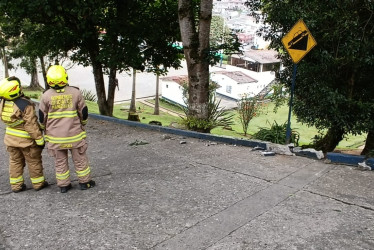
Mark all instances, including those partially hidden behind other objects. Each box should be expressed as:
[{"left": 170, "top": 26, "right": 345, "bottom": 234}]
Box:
[{"left": 0, "top": 76, "right": 48, "bottom": 193}]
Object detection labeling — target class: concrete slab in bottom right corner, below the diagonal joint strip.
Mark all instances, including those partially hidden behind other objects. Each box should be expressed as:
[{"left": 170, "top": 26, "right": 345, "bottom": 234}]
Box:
[{"left": 206, "top": 191, "right": 374, "bottom": 250}]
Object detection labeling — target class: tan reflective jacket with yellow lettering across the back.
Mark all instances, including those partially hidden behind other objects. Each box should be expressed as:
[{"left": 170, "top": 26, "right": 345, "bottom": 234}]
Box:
[{"left": 39, "top": 86, "right": 88, "bottom": 149}]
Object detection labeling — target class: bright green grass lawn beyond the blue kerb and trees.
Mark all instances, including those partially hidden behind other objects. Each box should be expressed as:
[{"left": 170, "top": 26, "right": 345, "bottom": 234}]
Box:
[{"left": 25, "top": 88, "right": 366, "bottom": 149}]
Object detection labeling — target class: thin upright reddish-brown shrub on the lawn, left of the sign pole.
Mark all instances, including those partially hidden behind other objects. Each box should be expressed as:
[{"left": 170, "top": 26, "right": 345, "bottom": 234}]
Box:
[{"left": 238, "top": 94, "right": 261, "bottom": 136}]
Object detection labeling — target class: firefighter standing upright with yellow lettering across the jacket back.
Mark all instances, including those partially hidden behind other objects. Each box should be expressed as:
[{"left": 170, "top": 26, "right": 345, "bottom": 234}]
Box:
[{"left": 39, "top": 65, "right": 95, "bottom": 193}]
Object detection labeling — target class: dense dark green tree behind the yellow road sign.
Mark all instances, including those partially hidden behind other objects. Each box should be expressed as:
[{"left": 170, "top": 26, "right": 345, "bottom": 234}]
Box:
[{"left": 247, "top": 0, "right": 374, "bottom": 152}]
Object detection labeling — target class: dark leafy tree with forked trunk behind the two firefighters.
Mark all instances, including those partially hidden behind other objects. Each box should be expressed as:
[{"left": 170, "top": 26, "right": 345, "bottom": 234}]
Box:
[{"left": 0, "top": 0, "right": 180, "bottom": 115}]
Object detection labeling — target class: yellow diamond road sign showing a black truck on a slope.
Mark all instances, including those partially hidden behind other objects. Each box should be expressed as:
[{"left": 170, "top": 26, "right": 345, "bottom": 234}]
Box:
[{"left": 282, "top": 19, "right": 317, "bottom": 63}]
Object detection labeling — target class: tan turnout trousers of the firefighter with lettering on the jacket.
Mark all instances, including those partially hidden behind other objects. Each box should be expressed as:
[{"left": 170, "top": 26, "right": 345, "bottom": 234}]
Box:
[{"left": 48, "top": 143, "right": 91, "bottom": 187}]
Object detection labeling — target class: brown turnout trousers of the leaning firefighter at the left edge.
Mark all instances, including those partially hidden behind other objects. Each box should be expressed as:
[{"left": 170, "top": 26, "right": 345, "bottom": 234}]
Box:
[{"left": 6, "top": 146, "right": 45, "bottom": 191}]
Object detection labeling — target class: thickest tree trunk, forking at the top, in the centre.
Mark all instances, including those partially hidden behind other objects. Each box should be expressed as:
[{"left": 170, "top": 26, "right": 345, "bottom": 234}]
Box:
[{"left": 178, "top": 0, "right": 213, "bottom": 119}]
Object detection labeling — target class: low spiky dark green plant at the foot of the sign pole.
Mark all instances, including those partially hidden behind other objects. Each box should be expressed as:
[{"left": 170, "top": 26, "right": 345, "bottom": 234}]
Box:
[{"left": 253, "top": 121, "right": 300, "bottom": 146}]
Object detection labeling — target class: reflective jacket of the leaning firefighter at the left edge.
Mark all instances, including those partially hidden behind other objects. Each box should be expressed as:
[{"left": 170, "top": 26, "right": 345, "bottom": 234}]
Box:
[{"left": 0, "top": 96, "right": 44, "bottom": 148}]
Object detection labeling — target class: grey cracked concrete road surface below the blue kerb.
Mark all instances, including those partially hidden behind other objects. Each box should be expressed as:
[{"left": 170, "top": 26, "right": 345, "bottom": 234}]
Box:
[{"left": 0, "top": 117, "right": 374, "bottom": 250}]
